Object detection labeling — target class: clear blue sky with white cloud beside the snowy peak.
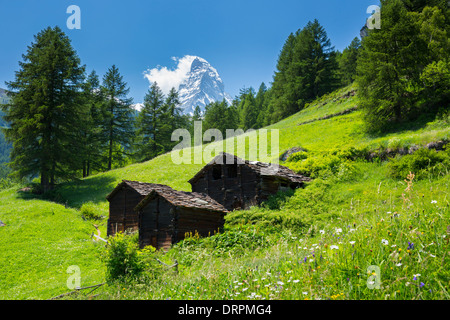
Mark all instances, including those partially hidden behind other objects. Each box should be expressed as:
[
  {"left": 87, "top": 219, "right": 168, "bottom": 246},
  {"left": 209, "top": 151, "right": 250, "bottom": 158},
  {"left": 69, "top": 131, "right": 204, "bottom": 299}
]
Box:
[{"left": 0, "top": 0, "right": 379, "bottom": 103}]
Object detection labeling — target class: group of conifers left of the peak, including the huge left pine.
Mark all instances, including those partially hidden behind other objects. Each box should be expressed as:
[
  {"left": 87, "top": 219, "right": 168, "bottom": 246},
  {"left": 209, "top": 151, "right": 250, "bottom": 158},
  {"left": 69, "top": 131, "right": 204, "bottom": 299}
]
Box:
[{"left": 1, "top": 27, "right": 188, "bottom": 192}]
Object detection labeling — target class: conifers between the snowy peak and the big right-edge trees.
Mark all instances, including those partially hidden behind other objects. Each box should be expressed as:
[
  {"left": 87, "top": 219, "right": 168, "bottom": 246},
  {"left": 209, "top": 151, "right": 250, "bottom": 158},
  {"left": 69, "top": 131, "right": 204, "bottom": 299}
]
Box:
[{"left": 203, "top": 19, "right": 361, "bottom": 130}]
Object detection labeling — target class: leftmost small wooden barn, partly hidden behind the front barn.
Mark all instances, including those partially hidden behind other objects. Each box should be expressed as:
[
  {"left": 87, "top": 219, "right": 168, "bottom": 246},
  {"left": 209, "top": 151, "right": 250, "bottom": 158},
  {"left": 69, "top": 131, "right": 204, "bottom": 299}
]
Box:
[{"left": 106, "top": 180, "right": 172, "bottom": 236}]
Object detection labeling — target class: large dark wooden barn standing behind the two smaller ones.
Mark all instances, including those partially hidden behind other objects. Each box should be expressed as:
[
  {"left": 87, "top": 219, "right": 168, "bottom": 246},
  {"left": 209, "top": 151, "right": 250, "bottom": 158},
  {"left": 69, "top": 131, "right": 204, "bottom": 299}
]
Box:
[{"left": 189, "top": 152, "right": 311, "bottom": 211}]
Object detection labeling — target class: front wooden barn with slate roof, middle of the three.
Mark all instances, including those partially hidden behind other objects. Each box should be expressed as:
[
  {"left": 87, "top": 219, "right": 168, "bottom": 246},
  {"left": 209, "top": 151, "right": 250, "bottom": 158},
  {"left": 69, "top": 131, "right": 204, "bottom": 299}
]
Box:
[{"left": 135, "top": 189, "right": 227, "bottom": 249}]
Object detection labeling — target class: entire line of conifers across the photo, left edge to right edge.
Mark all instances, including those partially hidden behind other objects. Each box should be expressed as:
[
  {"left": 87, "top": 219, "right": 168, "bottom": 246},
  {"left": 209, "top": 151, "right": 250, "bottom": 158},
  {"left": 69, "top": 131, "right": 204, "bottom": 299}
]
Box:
[{"left": 1, "top": 0, "right": 450, "bottom": 191}]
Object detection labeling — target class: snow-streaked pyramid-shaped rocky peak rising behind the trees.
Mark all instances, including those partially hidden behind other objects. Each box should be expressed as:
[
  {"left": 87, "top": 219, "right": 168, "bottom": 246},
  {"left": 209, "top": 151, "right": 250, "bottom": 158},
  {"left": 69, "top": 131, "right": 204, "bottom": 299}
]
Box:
[{"left": 178, "top": 57, "right": 232, "bottom": 114}]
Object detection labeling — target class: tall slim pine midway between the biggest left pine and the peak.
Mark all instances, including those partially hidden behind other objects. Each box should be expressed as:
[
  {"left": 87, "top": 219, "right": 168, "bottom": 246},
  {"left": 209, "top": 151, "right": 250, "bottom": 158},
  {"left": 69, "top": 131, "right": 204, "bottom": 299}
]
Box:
[{"left": 101, "top": 65, "right": 134, "bottom": 170}]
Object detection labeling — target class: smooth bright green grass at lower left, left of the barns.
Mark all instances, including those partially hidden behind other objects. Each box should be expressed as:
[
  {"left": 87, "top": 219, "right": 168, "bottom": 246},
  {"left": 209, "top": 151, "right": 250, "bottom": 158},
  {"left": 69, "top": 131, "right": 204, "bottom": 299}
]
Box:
[{"left": 0, "top": 188, "right": 105, "bottom": 299}]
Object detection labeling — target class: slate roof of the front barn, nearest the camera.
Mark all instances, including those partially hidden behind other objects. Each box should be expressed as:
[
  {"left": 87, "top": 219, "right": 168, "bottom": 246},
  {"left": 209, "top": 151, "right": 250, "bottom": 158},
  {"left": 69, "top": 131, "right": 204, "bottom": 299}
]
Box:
[{"left": 134, "top": 189, "right": 228, "bottom": 213}]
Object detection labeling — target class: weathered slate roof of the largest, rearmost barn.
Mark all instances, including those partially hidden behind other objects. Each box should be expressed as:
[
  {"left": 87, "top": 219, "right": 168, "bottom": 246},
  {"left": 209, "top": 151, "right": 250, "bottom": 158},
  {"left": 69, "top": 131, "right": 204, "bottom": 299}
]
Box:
[{"left": 188, "top": 152, "right": 311, "bottom": 184}]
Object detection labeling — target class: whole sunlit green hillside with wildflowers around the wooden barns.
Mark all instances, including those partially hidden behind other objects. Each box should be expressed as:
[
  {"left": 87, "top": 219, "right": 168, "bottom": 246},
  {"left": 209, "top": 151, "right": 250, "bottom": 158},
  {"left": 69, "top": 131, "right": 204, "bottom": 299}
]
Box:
[{"left": 0, "top": 87, "right": 450, "bottom": 299}]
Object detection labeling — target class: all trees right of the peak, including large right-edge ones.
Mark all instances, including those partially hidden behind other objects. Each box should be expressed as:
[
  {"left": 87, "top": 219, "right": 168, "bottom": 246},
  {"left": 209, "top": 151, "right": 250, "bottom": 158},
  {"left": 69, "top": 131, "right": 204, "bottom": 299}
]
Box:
[{"left": 203, "top": 0, "right": 450, "bottom": 132}]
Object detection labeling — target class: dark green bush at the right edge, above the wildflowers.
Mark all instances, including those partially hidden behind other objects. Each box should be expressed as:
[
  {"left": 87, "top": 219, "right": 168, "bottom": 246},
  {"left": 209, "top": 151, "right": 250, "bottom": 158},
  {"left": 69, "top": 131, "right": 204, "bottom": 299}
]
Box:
[{"left": 388, "top": 148, "right": 450, "bottom": 179}]
